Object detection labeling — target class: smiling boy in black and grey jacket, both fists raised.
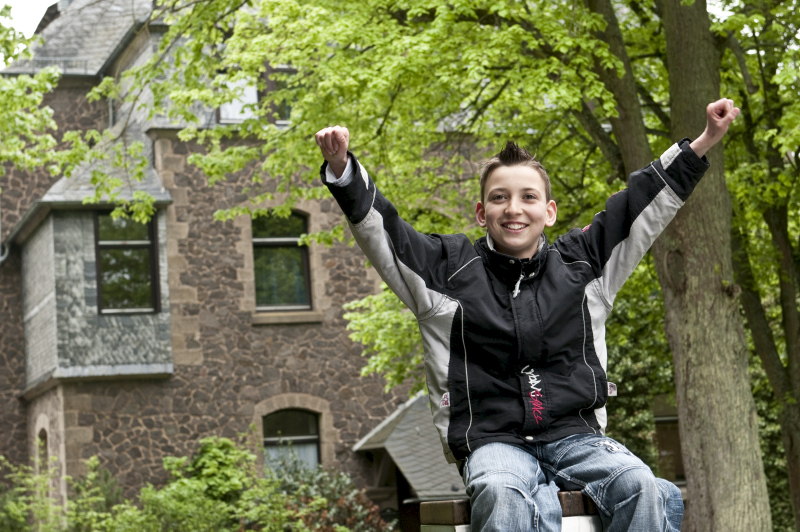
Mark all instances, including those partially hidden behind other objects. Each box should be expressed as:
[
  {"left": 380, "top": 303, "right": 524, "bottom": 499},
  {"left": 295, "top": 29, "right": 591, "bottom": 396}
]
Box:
[{"left": 316, "top": 99, "right": 739, "bottom": 531}]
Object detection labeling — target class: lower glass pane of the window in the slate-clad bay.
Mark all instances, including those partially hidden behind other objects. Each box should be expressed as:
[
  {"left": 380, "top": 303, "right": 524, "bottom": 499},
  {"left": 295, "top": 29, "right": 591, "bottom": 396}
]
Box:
[{"left": 99, "top": 248, "right": 153, "bottom": 309}]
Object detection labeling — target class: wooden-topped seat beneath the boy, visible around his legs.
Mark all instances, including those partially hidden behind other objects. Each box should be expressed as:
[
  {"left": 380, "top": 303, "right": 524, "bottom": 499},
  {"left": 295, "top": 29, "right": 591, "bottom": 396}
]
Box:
[{"left": 419, "top": 491, "right": 603, "bottom": 532}]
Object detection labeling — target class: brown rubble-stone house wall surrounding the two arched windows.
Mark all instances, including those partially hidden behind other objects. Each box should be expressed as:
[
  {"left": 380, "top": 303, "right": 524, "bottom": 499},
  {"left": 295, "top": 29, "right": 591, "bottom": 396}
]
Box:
[{"left": 58, "top": 136, "right": 406, "bottom": 495}]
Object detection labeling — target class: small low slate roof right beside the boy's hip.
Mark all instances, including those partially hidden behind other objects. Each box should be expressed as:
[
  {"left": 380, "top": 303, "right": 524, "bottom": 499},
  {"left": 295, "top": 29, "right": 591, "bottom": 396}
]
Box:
[{"left": 353, "top": 394, "right": 466, "bottom": 499}]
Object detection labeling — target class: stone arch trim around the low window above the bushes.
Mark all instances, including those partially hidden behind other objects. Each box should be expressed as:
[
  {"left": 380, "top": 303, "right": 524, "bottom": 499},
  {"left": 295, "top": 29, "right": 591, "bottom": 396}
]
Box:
[{"left": 253, "top": 393, "right": 339, "bottom": 469}]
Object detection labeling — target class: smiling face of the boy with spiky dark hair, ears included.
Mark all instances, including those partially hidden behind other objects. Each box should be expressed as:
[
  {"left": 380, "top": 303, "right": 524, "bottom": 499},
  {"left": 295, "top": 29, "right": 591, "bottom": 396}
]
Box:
[{"left": 475, "top": 166, "right": 557, "bottom": 259}]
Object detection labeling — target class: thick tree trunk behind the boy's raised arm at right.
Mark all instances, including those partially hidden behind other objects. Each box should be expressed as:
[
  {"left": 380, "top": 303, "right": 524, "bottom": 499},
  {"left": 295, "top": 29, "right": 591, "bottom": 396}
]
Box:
[{"left": 655, "top": 0, "right": 772, "bottom": 532}]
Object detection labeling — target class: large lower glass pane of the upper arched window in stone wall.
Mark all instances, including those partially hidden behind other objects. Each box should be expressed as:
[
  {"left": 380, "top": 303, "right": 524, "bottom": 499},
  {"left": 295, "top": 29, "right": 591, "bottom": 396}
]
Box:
[{"left": 253, "top": 246, "right": 310, "bottom": 306}]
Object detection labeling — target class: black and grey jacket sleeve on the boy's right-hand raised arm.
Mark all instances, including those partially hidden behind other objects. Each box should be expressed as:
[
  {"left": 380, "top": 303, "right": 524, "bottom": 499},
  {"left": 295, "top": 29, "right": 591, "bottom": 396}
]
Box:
[{"left": 576, "top": 139, "right": 709, "bottom": 308}]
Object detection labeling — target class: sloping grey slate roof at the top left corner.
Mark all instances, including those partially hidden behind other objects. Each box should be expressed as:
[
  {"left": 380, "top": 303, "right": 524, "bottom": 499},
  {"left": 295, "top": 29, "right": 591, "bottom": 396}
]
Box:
[{"left": 3, "top": 0, "right": 152, "bottom": 76}]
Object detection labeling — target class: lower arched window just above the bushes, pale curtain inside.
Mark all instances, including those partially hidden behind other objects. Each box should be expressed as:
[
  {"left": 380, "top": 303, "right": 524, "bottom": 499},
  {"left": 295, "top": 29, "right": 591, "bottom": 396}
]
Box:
[{"left": 264, "top": 409, "right": 319, "bottom": 467}]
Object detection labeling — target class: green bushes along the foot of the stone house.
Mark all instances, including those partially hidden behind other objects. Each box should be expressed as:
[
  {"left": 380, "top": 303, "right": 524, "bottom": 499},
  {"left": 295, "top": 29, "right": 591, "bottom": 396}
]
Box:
[{"left": 0, "top": 437, "right": 392, "bottom": 532}]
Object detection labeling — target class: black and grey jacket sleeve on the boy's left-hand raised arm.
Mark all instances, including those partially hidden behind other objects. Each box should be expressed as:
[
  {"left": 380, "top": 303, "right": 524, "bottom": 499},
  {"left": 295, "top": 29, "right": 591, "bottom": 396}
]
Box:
[{"left": 320, "top": 154, "right": 454, "bottom": 318}]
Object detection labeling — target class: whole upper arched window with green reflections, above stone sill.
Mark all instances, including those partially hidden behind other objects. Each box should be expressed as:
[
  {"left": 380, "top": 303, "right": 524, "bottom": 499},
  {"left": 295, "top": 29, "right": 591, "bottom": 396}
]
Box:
[{"left": 253, "top": 213, "right": 311, "bottom": 310}]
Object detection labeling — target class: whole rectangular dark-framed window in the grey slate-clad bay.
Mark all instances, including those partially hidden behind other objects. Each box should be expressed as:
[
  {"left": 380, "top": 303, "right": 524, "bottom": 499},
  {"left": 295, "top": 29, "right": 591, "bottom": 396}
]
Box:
[{"left": 95, "top": 213, "right": 159, "bottom": 314}]
